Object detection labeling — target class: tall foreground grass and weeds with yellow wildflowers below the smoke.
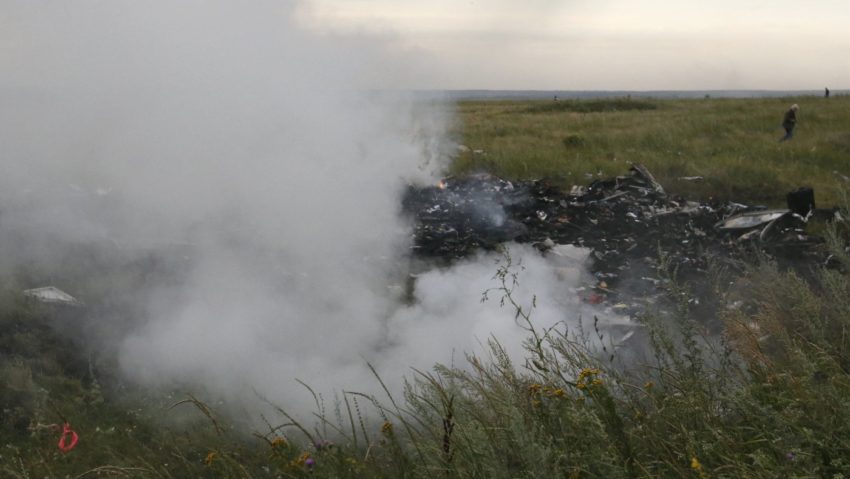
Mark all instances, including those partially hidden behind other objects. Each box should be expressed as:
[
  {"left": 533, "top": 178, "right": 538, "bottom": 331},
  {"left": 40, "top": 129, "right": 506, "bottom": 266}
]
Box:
[{"left": 0, "top": 211, "right": 850, "bottom": 478}]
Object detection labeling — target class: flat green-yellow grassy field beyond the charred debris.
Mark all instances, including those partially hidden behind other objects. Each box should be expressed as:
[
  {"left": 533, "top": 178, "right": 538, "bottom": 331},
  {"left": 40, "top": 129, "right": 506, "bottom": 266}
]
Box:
[{"left": 453, "top": 96, "right": 850, "bottom": 206}]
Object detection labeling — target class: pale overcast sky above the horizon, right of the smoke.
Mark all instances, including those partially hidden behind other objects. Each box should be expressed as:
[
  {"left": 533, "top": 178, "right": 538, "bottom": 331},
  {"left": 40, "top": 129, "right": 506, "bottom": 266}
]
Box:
[{"left": 298, "top": 0, "right": 850, "bottom": 90}]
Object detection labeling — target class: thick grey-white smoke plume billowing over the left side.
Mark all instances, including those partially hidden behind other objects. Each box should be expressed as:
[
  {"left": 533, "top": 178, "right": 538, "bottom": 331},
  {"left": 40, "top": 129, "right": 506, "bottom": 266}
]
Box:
[{"left": 0, "top": 1, "right": 608, "bottom": 424}]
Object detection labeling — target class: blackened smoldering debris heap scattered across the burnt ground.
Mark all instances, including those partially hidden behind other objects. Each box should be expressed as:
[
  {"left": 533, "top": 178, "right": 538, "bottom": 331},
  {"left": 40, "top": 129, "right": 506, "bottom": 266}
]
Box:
[{"left": 403, "top": 164, "right": 832, "bottom": 318}]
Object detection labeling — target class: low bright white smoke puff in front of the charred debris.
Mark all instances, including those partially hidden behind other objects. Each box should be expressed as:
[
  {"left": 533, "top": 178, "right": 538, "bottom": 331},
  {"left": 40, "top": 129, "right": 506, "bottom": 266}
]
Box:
[{"left": 381, "top": 243, "right": 594, "bottom": 376}]
